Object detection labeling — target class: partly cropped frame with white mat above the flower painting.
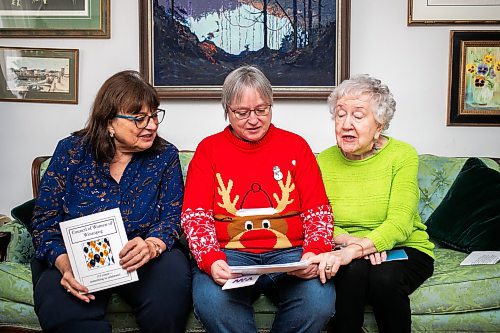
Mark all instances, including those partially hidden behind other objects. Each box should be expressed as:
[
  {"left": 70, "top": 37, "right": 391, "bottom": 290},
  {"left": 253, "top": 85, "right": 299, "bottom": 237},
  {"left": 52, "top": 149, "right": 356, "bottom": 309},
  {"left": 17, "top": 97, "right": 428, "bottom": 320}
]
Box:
[{"left": 408, "top": 0, "right": 500, "bottom": 25}]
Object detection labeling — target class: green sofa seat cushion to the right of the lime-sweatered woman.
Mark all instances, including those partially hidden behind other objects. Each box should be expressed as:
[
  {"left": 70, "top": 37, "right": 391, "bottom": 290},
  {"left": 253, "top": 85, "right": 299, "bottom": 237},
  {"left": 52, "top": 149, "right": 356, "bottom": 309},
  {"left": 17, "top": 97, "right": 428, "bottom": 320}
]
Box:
[{"left": 410, "top": 248, "right": 500, "bottom": 314}]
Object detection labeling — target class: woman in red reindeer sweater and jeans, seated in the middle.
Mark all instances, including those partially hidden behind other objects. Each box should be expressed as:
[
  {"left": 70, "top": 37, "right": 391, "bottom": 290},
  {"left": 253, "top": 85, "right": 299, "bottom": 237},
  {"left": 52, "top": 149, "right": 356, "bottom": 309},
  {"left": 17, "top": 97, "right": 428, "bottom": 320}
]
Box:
[{"left": 181, "top": 66, "right": 335, "bottom": 333}]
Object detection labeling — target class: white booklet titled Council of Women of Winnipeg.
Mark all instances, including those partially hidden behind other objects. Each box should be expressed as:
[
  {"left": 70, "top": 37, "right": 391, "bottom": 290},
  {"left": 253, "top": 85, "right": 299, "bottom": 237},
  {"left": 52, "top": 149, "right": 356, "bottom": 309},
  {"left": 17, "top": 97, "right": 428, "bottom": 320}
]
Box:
[{"left": 59, "top": 208, "right": 139, "bottom": 292}]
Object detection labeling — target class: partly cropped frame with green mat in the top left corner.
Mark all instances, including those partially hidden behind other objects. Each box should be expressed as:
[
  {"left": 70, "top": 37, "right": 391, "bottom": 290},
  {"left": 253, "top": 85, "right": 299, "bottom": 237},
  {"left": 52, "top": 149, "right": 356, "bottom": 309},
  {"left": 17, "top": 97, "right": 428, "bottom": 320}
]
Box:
[{"left": 0, "top": 0, "right": 110, "bottom": 38}]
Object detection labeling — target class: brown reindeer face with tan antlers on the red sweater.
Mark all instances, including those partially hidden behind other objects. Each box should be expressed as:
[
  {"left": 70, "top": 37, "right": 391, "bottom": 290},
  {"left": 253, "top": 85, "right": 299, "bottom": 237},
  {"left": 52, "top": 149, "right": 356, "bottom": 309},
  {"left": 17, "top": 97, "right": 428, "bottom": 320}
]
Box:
[{"left": 215, "top": 167, "right": 297, "bottom": 250}]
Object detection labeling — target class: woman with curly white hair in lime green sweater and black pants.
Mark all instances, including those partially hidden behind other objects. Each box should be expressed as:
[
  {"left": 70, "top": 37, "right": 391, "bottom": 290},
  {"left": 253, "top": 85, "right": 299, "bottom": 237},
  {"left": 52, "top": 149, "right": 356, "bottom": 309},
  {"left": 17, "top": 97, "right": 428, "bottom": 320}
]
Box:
[{"left": 309, "top": 75, "right": 434, "bottom": 333}]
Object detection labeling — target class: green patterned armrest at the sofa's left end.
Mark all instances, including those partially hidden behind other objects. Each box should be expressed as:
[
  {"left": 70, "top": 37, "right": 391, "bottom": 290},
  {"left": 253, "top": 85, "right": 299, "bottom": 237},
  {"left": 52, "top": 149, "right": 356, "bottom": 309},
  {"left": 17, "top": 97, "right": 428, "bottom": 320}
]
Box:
[{"left": 0, "top": 220, "right": 34, "bottom": 264}]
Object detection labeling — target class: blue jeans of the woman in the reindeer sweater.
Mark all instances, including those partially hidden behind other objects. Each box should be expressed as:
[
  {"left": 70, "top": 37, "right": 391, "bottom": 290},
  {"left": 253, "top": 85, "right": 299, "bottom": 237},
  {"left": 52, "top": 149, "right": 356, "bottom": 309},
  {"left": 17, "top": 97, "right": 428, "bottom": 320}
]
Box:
[{"left": 192, "top": 248, "right": 335, "bottom": 333}]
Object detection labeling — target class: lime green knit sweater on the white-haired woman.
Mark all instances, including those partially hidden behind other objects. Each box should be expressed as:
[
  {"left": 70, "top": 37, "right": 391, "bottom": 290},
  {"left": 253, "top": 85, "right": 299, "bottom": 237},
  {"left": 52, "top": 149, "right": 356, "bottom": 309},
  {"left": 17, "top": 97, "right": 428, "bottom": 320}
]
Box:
[{"left": 318, "top": 138, "right": 434, "bottom": 258}]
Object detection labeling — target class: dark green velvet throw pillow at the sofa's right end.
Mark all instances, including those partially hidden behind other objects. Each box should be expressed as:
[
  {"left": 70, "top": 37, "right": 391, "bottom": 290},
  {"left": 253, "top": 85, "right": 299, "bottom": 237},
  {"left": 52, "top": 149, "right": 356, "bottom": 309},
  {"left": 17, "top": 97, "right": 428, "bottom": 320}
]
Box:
[{"left": 426, "top": 157, "right": 500, "bottom": 253}]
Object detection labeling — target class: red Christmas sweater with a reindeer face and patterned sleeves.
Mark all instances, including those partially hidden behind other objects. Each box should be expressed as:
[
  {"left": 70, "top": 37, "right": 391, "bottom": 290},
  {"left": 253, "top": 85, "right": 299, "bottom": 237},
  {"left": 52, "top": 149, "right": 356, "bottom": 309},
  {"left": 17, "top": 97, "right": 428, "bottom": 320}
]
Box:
[{"left": 182, "top": 125, "right": 333, "bottom": 274}]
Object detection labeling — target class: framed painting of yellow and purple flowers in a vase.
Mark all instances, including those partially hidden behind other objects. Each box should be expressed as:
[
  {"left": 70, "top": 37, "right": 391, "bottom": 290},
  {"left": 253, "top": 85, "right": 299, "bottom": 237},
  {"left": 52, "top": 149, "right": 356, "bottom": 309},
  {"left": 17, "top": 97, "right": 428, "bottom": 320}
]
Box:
[{"left": 447, "top": 30, "right": 500, "bottom": 126}]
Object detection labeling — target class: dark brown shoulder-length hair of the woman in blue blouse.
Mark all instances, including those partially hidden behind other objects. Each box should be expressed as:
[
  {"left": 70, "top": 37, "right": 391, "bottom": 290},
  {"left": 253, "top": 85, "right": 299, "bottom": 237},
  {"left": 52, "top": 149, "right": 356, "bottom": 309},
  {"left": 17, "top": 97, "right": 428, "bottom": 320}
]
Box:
[{"left": 73, "top": 70, "right": 165, "bottom": 162}]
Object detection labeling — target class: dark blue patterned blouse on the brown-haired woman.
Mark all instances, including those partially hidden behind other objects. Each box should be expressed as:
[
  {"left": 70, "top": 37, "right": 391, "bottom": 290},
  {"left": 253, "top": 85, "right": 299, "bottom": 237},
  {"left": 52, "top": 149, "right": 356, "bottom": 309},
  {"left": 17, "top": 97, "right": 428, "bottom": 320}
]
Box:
[{"left": 32, "top": 135, "right": 184, "bottom": 266}]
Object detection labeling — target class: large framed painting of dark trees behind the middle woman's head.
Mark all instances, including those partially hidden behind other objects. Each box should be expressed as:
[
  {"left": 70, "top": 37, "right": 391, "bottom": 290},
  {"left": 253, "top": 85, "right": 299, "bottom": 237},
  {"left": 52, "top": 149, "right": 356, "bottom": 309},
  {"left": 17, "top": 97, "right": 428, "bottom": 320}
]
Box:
[{"left": 139, "top": 0, "right": 350, "bottom": 98}]
